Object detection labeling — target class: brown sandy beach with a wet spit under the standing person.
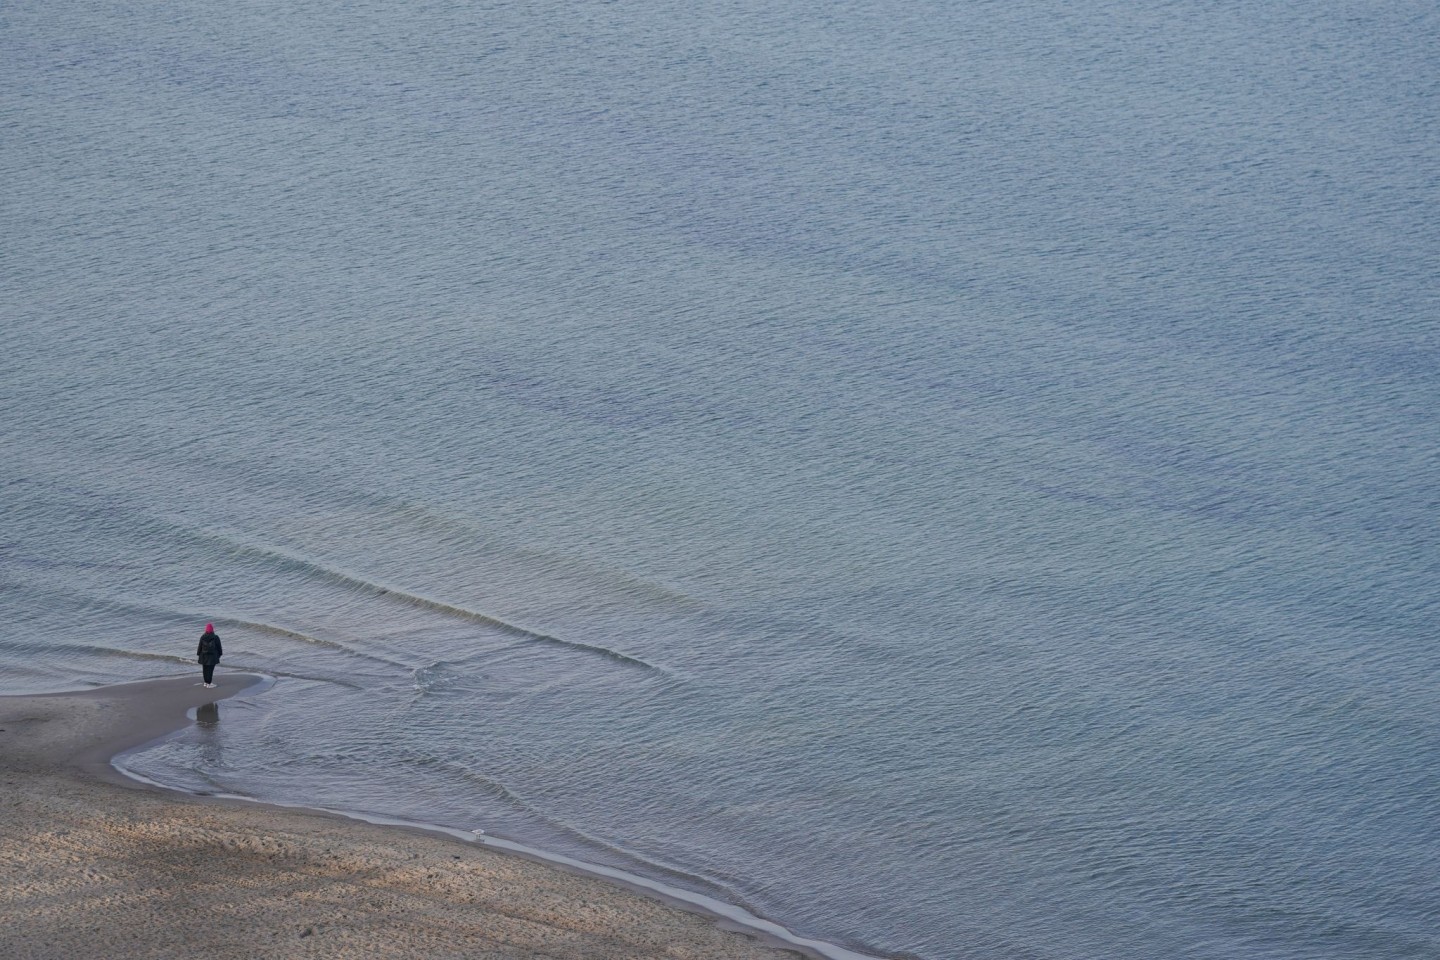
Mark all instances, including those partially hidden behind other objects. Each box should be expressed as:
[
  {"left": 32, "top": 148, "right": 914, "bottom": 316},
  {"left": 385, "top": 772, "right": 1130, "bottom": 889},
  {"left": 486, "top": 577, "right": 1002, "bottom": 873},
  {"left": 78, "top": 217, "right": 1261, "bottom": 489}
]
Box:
[{"left": 0, "top": 674, "right": 801, "bottom": 960}]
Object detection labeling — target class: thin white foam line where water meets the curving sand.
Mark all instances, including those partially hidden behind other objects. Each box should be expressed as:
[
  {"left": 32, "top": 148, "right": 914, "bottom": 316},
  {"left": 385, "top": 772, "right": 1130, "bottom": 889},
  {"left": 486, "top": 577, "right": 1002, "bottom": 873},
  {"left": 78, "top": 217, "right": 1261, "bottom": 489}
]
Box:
[{"left": 111, "top": 759, "right": 881, "bottom": 960}]
